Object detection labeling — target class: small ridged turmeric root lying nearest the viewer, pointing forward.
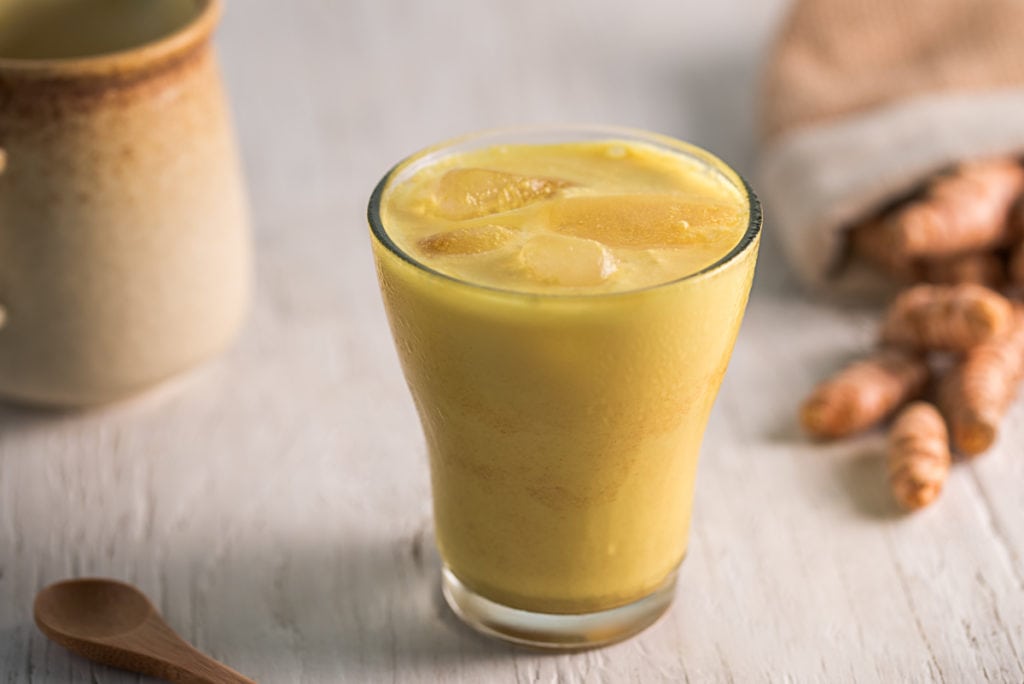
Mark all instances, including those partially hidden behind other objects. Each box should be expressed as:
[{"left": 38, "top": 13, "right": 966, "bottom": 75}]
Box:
[{"left": 888, "top": 401, "right": 950, "bottom": 510}]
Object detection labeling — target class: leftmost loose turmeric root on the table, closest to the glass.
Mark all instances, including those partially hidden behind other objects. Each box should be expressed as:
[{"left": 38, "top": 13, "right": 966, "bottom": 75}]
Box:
[{"left": 800, "top": 349, "right": 928, "bottom": 439}]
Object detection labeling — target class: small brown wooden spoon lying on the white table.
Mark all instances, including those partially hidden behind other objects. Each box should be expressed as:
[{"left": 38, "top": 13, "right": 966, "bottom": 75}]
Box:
[{"left": 34, "top": 580, "right": 254, "bottom": 684}]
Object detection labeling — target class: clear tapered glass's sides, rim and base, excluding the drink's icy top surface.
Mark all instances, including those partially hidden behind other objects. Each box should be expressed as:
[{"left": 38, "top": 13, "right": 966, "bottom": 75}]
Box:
[{"left": 369, "top": 126, "right": 761, "bottom": 648}]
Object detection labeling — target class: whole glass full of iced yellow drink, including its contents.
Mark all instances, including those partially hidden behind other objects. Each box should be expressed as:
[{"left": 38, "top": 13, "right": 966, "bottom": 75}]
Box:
[{"left": 370, "top": 129, "right": 760, "bottom": 646}]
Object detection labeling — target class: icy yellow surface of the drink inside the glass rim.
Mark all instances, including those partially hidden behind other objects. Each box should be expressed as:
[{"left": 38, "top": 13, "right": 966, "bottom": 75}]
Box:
[{"left": 382, "top": 140, "right": 749, "bottom": 294}]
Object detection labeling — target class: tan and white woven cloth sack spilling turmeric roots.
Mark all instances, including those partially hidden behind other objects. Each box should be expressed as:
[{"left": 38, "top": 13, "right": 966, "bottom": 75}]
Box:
[{"left": 757, "top": 0, "right": 1024, "bottom": 284}]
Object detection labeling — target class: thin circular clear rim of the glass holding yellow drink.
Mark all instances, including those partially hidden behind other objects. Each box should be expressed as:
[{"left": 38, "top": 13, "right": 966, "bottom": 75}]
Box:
[{"left": 367, "top": 124, "right": 764, "bottom": 299}]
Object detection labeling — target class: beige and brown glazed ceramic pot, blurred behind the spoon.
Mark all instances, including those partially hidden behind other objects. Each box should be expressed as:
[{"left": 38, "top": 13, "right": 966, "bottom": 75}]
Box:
[{"left": 0, "top": 0, "right": 250, "bottom": 407}]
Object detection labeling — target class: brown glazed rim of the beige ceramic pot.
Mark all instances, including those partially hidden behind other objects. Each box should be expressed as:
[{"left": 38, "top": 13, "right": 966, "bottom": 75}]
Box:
[{"left": 0, "top": 0, "right": 223, "bottom": 78}]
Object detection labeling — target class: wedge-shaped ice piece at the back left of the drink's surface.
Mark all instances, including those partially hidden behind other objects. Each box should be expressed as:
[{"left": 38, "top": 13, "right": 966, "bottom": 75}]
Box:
[{"left": 434, "top": 168, "right": 569, "bottom": 220}]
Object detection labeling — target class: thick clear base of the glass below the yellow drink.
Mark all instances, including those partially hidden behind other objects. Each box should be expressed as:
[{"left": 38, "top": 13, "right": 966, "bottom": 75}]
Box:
[{"left": 441, "top": 566, "right": 676, "bottom": 650}]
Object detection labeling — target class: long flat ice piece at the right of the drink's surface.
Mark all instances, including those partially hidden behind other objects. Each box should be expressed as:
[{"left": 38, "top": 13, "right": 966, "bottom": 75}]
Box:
[{"left": 548, "top": 195, "right": 742, "bottom": 247}]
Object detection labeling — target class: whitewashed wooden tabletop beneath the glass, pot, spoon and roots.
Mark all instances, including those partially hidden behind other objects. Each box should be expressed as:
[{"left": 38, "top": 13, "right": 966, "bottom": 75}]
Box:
[{"left": 0, "top": 0, "right": 1024, "bottom": 684}]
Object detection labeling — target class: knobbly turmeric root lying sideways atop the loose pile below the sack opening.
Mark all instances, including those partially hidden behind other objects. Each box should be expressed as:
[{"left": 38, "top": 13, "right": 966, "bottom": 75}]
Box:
[{"left": 882, "top": 284, "right": 1013, "bottom": 351}]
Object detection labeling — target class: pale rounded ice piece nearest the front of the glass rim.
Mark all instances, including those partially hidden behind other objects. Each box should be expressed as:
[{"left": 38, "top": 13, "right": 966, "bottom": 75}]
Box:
[{"left": 519, "top": 232, "right": 615, "bottom": 287}]
